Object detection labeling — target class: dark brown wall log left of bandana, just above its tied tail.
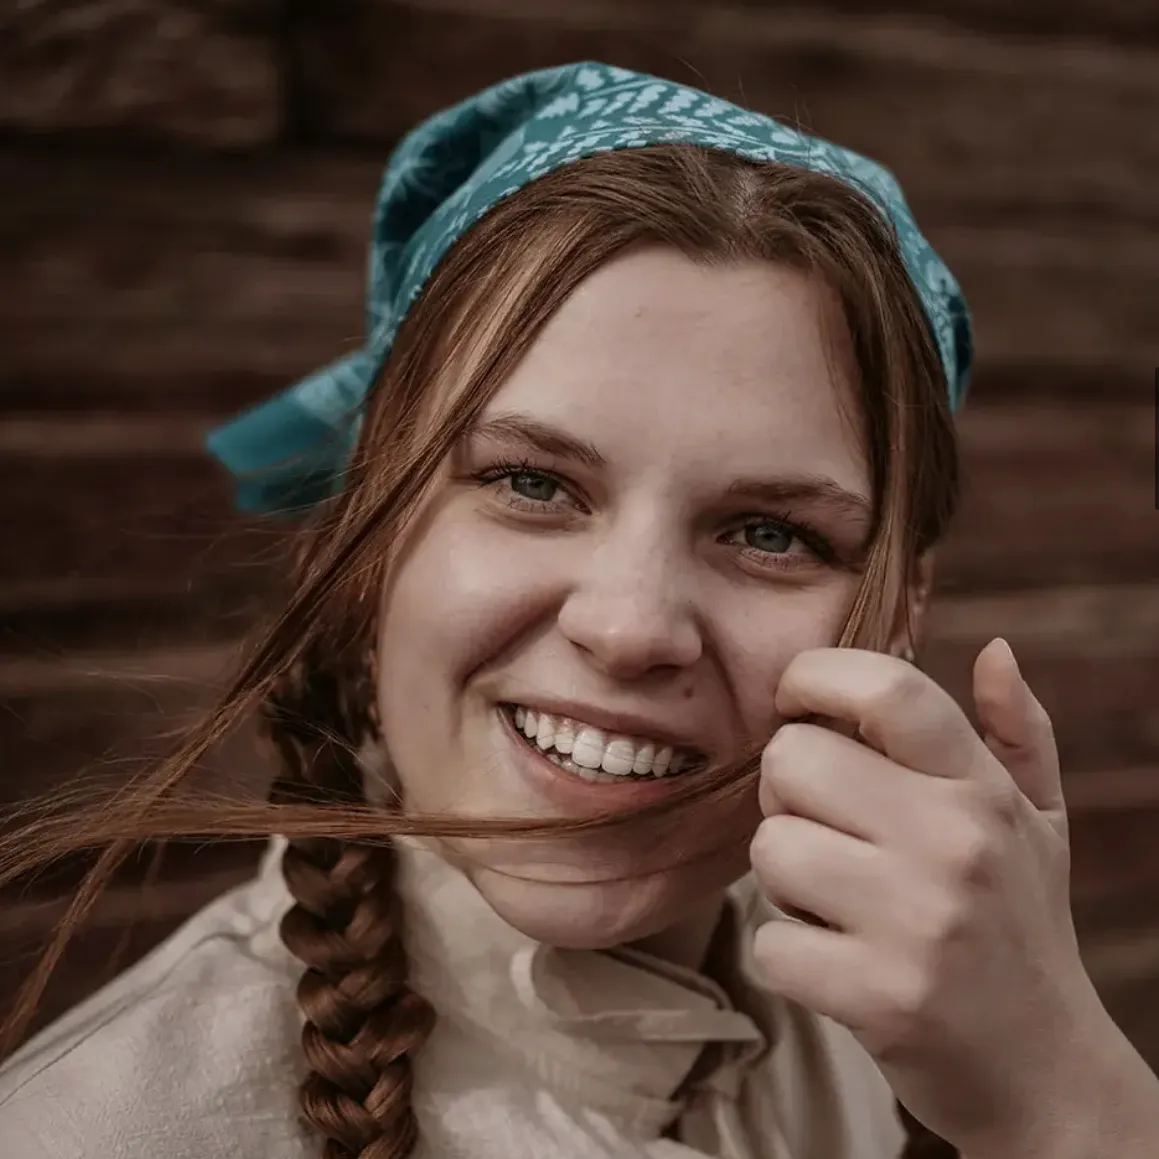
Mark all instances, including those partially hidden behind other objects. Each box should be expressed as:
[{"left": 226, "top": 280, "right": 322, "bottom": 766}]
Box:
[{"left": 0, "top": 147, "right": 381, "bottom": 414}]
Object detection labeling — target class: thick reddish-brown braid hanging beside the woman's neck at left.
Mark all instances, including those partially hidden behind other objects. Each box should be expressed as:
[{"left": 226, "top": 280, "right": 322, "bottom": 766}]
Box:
[{"left": 263, "top": 659, "right": 435, "bottom": 1159}]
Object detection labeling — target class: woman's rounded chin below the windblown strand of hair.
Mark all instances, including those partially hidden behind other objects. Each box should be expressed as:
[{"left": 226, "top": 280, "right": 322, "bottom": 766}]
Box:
[{"left": 468, "top": 866, "right": 681, "bottom": 949}]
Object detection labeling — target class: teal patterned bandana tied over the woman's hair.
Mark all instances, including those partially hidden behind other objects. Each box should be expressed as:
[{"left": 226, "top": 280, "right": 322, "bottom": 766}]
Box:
[{"left": 207, "top": 64, "right": 971, "bottom": 512}]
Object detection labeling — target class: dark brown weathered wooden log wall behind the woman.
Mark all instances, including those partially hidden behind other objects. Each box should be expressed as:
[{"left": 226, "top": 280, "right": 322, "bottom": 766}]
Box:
[{"left": 0, "top": 0, "right": 1159, "bottom": 1066}]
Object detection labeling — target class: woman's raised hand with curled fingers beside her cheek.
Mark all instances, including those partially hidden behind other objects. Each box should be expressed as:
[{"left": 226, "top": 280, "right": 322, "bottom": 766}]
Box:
[{"left": 751, "top": 640, "right": 1145, "bottom": 1159}]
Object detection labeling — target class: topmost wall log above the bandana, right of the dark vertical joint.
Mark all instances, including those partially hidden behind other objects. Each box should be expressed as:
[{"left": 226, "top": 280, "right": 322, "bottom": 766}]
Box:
[{"left": 293, "top": 0, "right": 1159, "bottom": 229}]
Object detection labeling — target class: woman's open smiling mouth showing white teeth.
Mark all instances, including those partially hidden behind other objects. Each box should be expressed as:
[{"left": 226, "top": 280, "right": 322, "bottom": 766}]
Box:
[{"left": 500, "top": 704, "right": 708, "bottom": 785}]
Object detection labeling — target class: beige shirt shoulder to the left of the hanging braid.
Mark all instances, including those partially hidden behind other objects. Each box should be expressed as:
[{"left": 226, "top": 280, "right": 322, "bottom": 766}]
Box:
[{"left": 0, "top": 853, "right": 305, "bottom": 1159}]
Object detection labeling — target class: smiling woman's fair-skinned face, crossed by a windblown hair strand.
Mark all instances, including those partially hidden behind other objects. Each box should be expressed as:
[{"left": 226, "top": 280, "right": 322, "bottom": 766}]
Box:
[{"left": 379, "top": 249, "right": 870, "bottom": 947}]
